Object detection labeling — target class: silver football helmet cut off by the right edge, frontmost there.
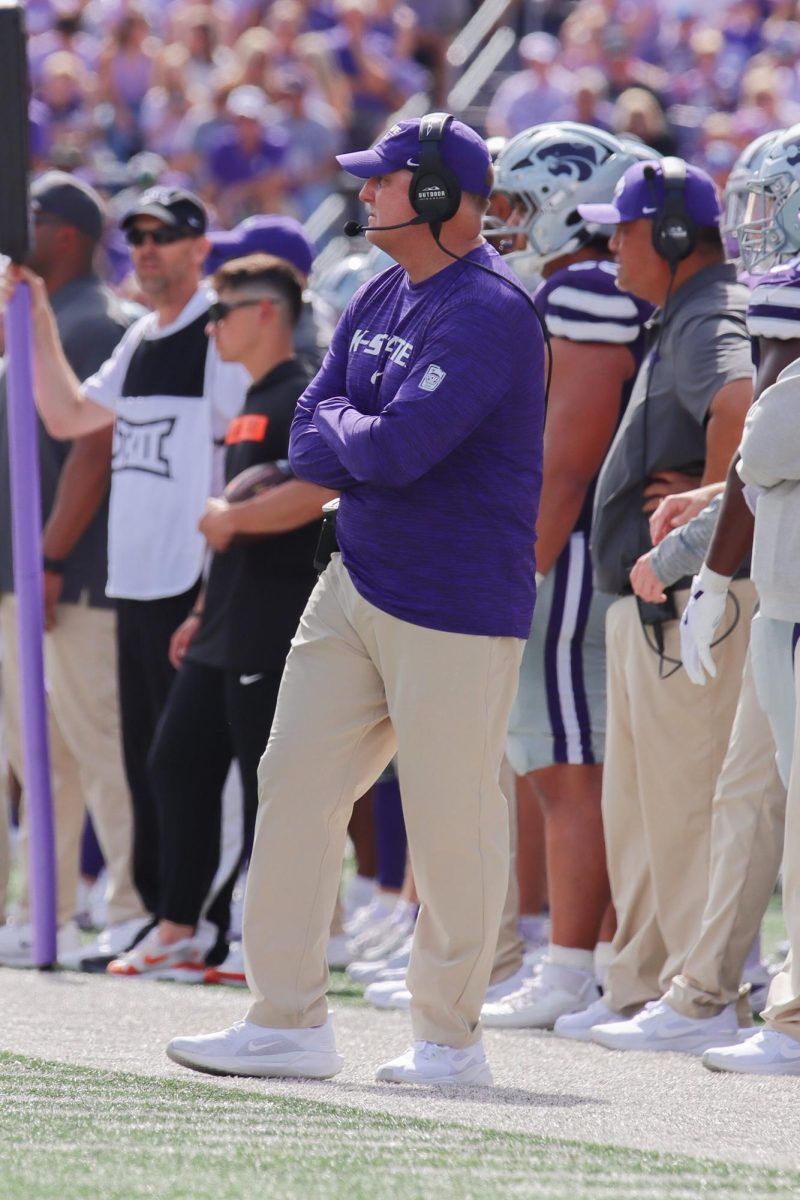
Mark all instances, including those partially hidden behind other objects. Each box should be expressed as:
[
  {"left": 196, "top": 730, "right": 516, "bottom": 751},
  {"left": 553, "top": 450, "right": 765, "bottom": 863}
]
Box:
[{"left": 736, "top": 125, "right": 800, "bottom": 274}]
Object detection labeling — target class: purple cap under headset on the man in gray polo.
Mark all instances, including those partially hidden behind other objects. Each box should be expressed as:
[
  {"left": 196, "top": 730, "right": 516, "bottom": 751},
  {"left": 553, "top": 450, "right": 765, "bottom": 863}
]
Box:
[{"left": 578, "top": 158, "right": 721, "bottom": 226}]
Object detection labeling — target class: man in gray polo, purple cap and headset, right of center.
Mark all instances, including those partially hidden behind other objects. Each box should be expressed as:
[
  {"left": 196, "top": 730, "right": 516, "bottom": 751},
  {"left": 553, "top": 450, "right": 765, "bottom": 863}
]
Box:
[{"left": 555, "top": 158, "right": 753, "bottom": 1040}]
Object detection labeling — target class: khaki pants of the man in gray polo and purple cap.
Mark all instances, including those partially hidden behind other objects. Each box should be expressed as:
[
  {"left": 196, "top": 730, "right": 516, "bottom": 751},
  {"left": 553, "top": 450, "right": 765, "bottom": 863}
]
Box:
[{"left": 602, "top": 580, "right": 754, "bottom": 1013}]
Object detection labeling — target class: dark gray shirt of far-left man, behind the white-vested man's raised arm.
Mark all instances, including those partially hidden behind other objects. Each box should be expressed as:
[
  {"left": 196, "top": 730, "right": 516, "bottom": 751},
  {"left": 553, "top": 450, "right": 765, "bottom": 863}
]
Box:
[{"left": 0, "top": 275, "right": 132, "bottom": 607}]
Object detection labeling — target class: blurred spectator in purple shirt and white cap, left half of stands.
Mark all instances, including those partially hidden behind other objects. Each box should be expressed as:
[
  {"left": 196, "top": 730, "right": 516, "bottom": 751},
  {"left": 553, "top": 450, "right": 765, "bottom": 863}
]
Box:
[{"left": 205, "top": 84, "right": 287, "bottom": 224}]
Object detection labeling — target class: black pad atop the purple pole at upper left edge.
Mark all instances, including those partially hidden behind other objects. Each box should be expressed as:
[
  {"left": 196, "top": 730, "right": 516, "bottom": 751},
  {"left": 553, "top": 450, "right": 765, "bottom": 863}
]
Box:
[{"left": 0, "top": 2, "right": 30, "bottom": 263}]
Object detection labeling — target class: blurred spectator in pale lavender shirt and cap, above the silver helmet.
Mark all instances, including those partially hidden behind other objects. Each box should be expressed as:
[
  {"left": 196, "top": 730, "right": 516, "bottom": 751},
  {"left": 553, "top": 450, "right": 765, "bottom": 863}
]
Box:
[{"left": 486, "top": 34, "right": 573, "bottom": 138}]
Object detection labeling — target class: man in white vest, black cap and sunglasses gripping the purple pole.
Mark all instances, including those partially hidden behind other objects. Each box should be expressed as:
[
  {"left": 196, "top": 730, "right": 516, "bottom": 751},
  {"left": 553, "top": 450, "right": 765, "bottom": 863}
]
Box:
[{"left": 7, "top": 187, "right": 249, "bottom": 936}]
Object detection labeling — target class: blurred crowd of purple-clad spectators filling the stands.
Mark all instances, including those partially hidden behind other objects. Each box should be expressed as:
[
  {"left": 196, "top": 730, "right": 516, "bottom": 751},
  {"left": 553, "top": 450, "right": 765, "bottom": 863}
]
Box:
[{"left": 20, "top": 0, "right": 800, "bottom": 247}]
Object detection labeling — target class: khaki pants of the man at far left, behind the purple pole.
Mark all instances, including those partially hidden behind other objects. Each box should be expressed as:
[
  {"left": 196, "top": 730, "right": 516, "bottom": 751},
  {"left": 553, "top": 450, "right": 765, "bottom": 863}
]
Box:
[{"left": 0, "top": 594, "right": 144, "bottom": 925}]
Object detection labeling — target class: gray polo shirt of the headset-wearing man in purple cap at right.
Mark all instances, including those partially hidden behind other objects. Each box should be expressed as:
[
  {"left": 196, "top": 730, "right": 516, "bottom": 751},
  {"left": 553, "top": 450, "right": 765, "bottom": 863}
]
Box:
[{"left": 591, "top": 263, "right": 753, "bottom": 595}]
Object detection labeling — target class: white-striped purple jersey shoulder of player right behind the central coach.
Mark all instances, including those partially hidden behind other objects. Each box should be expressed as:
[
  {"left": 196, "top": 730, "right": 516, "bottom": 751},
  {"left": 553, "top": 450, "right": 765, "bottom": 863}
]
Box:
[{"left": 535, "top": 260, "right": 652, "bottom": 346}]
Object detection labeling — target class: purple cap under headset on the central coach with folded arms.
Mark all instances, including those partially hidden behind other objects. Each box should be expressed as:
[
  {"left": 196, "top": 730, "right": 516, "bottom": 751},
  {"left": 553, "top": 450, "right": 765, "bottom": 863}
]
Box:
[{"left": 336, "top": 118, "right": 492, "bottom": 196}]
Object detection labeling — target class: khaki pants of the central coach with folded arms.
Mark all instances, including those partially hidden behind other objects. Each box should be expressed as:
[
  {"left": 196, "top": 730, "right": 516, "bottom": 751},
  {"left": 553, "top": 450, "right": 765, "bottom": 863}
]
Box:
[{"left": 243, "top": 556, "right": 524, "bottom": 1046}]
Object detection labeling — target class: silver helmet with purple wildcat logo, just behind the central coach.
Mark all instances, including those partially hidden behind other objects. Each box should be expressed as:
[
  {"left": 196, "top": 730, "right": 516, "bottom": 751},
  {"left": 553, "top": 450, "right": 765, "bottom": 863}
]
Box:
[{"left": 485, "top": 121, "right": 661, "bottom": 270}]
